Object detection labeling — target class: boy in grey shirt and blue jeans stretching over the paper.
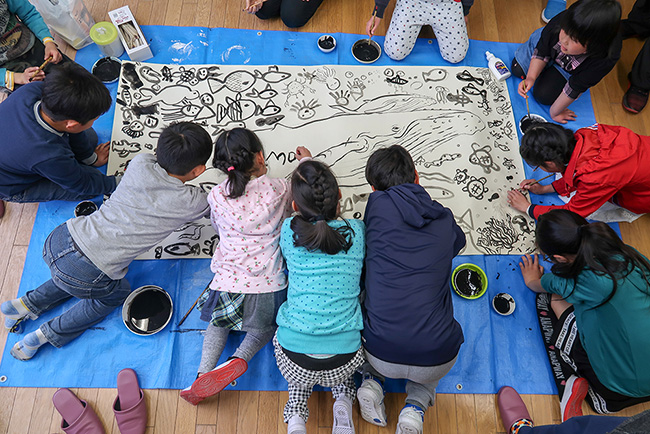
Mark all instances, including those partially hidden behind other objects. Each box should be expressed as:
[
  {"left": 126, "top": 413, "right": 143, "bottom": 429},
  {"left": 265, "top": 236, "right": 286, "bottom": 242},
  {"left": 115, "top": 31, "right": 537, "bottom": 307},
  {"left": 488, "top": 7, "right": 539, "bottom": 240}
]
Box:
[{"left": 0, "top": 122, "right": 212, "bottom": 360}]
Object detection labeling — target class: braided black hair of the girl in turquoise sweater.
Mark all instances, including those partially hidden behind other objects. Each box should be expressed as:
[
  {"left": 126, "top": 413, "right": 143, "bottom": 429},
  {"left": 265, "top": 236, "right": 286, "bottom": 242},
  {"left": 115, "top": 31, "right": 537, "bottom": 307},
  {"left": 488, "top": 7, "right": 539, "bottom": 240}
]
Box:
[{"left": 291, "top": 160, "right": 354, "bottom": 255}]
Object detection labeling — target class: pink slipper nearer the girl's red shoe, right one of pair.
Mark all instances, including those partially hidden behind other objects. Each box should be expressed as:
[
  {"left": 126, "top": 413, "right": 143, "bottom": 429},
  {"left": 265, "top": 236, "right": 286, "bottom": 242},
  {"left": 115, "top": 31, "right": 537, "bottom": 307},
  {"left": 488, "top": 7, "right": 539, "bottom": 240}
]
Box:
[{"left": 113, "top": 368, "right": 147, "bottom": 434}]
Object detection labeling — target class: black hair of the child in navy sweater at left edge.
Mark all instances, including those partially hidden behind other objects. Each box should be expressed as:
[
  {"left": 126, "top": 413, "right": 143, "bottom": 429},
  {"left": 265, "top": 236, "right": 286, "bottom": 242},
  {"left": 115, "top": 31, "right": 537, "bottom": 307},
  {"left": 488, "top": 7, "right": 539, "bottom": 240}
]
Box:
[{"left": 41, "top": 62, "right": 111, "bottom": 125}]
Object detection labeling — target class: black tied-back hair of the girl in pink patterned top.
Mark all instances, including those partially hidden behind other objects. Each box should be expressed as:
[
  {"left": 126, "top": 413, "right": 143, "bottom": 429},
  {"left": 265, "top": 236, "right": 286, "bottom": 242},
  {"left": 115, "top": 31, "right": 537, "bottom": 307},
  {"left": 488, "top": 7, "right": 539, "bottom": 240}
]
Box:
[{"left": 212, "top": 128, "right": 264, "bottom": 199}]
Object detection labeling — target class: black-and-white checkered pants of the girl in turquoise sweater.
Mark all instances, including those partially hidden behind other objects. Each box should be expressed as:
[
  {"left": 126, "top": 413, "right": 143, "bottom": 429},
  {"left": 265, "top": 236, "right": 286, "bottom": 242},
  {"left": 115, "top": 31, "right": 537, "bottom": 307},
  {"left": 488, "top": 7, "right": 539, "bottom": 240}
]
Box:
[{"left": 273, "top": 335, "right": 365, "bottom": 422}]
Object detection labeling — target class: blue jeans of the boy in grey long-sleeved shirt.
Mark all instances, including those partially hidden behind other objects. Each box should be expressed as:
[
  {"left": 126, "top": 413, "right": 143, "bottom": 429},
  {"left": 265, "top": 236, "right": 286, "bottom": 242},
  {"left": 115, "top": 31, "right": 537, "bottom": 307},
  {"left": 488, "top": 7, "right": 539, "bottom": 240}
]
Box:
[{"left": 22, "top": 223, "right": 131, "bottom": 348}]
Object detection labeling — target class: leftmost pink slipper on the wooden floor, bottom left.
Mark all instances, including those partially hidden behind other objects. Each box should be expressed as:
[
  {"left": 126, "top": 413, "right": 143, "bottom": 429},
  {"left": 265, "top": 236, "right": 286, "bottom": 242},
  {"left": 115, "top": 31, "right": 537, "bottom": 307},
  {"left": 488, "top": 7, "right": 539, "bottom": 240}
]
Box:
[{"left": 52, "top": 389, "right": 105, "bottom": 434}]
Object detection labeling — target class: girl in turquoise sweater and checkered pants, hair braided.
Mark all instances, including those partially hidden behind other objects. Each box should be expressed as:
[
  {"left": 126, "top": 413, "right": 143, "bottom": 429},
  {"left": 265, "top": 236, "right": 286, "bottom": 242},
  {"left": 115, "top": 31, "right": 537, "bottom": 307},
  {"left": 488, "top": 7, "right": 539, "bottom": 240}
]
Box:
[{"left": 273, "top": 160, "right": 365, "bottom": 434}]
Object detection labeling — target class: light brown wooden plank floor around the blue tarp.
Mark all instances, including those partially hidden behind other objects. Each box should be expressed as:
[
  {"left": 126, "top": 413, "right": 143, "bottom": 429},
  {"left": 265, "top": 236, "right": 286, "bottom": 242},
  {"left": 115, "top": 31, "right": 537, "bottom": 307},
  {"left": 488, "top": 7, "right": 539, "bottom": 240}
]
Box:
[{"left": 0, "top": 0, "right": 650, "bottom": 434}]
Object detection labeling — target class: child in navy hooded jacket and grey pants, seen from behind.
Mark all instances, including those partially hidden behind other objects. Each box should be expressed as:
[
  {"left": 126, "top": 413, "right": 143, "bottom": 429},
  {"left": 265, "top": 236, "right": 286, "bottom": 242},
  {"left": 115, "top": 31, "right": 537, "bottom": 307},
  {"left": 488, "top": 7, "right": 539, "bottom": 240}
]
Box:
[{"left": 357, "top": 145, "right": 465, "bottom": 434}]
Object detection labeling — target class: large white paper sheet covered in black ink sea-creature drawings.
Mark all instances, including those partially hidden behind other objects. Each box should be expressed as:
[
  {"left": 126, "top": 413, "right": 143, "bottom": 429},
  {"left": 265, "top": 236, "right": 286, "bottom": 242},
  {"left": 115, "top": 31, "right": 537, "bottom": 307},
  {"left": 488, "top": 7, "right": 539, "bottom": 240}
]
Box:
[{"left": 107, "top": 61, "right": 534, "bottom": 259}]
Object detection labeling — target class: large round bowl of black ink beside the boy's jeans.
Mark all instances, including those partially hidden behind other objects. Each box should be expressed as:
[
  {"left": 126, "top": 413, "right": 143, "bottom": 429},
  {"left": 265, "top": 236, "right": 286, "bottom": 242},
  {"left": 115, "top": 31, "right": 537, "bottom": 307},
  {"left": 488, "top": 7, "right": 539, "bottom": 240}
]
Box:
[{"left": 122, "top": 285, "right": 174, "bottom": 336}]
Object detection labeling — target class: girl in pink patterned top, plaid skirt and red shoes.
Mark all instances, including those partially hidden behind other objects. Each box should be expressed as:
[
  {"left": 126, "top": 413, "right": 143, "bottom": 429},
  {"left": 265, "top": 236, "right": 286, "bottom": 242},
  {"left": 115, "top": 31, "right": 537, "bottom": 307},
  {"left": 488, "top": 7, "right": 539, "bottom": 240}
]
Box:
[{"left": 181, "top": 128, "right": 311, "bottom": 405}]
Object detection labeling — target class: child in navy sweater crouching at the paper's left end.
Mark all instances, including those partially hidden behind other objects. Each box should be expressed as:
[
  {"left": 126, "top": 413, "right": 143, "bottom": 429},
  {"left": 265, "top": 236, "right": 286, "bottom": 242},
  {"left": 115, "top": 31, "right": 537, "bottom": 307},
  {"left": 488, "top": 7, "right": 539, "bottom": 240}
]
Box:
[{"left": 0, "top": 62, "right": 117, "bottom": 217}]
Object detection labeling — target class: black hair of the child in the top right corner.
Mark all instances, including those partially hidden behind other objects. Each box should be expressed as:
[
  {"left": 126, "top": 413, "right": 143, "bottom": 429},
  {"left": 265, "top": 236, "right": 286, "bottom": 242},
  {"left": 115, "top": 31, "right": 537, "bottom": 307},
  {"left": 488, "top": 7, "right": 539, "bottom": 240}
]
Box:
[{"left": 560, "top": 0, "right": 621, "bottom": 57}]
